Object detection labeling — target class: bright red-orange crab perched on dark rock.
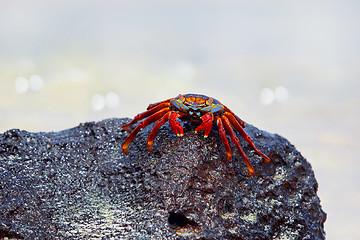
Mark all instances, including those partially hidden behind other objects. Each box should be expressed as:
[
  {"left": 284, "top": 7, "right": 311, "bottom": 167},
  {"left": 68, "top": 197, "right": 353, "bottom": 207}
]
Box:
[{"left": 122, "top": 94, "right": 270, "bottom": 177}]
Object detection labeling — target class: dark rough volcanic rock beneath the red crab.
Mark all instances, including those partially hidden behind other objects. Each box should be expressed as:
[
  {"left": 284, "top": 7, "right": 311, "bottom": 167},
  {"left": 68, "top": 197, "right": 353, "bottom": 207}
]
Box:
[{"left": 0, "top": 119, "right": 326, "bottom": 240}]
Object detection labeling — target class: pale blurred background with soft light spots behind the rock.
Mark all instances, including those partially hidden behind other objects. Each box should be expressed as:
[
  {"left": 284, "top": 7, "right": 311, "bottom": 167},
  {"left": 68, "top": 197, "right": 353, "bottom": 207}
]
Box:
[{"left": 0, "top": 0, "right": 360, "bottom": 239}]
